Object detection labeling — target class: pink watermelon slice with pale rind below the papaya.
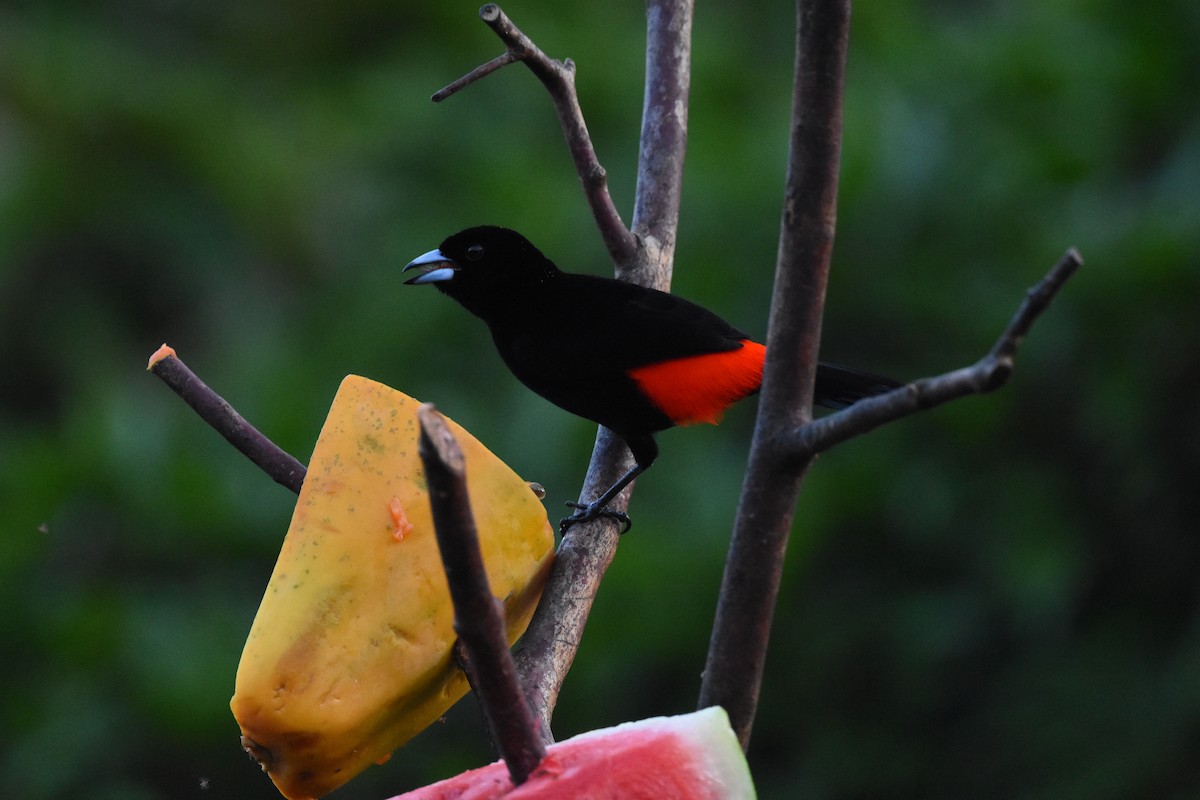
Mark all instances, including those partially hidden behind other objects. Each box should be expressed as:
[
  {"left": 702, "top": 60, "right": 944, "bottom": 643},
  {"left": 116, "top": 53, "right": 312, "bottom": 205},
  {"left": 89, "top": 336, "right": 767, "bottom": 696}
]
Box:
[{"left": 391, "top": 706, "right": 755, "bottom": 800}]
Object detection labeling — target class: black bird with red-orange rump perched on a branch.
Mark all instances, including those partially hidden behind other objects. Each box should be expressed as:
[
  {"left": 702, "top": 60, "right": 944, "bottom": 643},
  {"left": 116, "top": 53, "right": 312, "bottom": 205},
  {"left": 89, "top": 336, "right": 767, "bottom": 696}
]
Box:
[{"left": 404, "top": 225, "right": 900, "bottom": 533}]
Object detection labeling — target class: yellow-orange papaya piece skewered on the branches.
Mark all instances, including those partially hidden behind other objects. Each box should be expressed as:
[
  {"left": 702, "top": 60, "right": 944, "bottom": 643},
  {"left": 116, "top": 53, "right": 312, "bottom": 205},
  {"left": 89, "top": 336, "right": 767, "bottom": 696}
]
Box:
[{"left": 230, "top": 375, "right": 554, "bottom": 800}]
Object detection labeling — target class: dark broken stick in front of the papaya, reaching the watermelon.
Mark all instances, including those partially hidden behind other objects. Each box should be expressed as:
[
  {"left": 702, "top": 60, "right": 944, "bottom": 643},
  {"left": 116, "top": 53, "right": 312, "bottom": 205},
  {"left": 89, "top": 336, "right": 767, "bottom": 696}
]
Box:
[{"left": 418, "top": 403, "right": 546, "bottom": 786}]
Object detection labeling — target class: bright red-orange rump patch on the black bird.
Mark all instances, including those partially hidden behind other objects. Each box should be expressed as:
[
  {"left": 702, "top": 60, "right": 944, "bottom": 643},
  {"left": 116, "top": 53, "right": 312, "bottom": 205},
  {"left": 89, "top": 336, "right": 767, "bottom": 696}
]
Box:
[{"left": 629, "top": 339, "right": 767, "bottom": 425}]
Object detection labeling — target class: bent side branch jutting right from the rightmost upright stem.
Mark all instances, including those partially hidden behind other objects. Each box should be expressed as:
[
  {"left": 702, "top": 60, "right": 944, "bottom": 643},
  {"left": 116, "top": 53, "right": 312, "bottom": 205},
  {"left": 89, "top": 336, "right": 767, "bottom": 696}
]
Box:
[{"left": 786, "top": 248, "right": 1084, "bottom": 462}]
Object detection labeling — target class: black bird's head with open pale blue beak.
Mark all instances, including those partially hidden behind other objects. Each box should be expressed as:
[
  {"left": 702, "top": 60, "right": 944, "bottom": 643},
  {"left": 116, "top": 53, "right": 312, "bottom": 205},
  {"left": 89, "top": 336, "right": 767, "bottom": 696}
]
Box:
[{"left": 404, "top": 225, "right": 559, "bottom": 320}]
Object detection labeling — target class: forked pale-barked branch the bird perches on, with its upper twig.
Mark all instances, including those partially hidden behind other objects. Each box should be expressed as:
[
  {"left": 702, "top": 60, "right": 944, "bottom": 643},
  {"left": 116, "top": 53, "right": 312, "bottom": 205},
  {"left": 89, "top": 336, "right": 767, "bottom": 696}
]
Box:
[{"left": 434, "top": 0, "right": 692, "bottom": 741}]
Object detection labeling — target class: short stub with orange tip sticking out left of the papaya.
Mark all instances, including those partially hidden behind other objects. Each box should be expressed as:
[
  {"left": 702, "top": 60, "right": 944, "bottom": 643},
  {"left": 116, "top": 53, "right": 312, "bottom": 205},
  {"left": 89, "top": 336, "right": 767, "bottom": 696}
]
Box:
[{"left": 146, "top": 344, "right": 308, "bottom": 494}]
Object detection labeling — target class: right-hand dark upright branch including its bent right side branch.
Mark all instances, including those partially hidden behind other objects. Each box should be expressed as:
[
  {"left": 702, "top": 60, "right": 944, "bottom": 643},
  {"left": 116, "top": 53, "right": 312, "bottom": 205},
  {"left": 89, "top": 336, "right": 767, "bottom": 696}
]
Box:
[{"left": 700, "top": 0, "right": 1082, "bottom": 746}]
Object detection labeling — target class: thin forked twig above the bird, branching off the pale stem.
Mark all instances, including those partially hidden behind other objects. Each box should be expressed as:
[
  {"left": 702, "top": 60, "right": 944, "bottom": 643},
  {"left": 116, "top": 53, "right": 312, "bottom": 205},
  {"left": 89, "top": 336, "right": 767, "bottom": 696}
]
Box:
[{"left": 433, "top": 2, "right": 638, "bottom": 264}]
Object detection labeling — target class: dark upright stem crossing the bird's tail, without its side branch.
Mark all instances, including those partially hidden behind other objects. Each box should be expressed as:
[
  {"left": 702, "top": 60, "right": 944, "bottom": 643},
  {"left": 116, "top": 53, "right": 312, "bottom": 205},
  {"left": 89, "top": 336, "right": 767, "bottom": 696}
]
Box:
[{"left": 700, "top": 0, "right": 850, "bottom": 747}]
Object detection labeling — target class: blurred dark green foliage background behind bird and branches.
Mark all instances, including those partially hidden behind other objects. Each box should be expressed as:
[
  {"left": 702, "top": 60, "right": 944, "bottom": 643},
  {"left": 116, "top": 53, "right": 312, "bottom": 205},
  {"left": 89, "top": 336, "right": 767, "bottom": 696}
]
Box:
[{"left": 0, "top": 0, "right": 1200, "bottom": 800}]
